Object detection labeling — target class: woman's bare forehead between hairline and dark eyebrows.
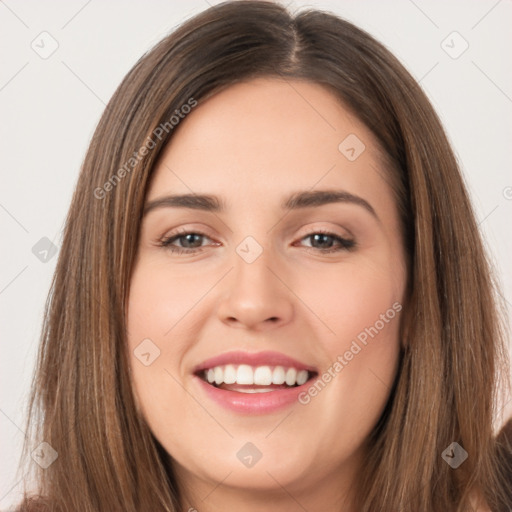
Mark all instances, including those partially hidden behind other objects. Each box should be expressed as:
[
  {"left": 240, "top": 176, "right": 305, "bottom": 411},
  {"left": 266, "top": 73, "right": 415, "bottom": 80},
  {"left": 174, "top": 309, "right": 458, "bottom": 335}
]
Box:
[{"left": 148, "top": 78, "right": 385, "bottom": 208}]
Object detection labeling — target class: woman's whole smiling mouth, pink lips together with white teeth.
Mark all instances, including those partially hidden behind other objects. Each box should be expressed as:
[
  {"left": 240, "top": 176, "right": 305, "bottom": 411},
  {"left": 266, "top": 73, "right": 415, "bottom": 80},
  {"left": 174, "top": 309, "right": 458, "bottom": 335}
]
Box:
[{"left": 194, "top": 352, "right": 318, "bottom": 414}]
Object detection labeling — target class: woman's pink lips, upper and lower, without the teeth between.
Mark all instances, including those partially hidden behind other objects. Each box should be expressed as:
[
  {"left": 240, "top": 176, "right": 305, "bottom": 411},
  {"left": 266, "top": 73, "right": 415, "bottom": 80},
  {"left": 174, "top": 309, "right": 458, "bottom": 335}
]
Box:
[{"left": 194, "top": 351, "right": 318, "bottom": 414}]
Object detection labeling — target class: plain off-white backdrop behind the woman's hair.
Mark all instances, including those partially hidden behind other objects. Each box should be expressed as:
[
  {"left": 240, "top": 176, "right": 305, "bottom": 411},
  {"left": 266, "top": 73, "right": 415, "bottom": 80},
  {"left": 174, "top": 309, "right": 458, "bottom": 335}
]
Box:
[{"left": 0, "top": 0, "right": 512, "bottom": 509}]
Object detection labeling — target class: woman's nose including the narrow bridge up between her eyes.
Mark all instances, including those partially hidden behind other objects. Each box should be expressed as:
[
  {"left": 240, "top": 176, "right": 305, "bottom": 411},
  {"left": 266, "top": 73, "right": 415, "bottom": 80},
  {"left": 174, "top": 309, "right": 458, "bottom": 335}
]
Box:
[{"left": 219, "top": 236, "right": 293, "bottom": 328}]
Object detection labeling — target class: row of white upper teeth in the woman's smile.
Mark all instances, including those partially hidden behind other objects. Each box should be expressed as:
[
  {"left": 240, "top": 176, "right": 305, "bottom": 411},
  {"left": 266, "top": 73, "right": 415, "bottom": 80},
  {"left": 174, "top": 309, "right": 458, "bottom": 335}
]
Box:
[{"left": 205, "top": 364, "right": 308, "bottom": 386}]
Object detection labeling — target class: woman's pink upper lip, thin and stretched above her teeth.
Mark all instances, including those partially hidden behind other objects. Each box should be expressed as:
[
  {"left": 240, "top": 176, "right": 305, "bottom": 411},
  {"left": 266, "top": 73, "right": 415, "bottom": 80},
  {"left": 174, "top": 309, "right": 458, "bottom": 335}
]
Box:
[{"left": 194, "top": 351, "right": 316, "bottom": 373}]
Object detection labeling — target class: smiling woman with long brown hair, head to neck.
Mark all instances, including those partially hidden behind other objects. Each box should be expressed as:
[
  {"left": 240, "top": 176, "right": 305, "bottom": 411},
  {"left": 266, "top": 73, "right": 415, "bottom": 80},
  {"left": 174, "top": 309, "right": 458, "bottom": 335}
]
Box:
[{"left": 16, "top": 1, "right": 512, "bottom": 512}]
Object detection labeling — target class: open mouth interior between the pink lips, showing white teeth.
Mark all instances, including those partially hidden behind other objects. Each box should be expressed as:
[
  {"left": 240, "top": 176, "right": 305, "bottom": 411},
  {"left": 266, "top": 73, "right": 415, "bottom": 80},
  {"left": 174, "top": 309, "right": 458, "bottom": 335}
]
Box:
[{"left": 196, "top": 364, "right": 316, "bottom": 393}]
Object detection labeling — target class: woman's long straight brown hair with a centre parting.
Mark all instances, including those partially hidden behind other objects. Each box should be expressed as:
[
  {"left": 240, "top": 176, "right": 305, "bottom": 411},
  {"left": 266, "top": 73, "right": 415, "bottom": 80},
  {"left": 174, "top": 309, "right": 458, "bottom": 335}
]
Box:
[{"left": 16, "top": 1, "right": 512, "bottom": 512}]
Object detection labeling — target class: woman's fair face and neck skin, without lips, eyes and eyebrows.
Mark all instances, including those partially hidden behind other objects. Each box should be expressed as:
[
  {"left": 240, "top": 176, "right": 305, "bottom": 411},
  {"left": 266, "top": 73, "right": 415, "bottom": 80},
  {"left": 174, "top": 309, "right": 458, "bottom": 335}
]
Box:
[{"left": 128, "top": 78, "right": 407, "bottom": 512}]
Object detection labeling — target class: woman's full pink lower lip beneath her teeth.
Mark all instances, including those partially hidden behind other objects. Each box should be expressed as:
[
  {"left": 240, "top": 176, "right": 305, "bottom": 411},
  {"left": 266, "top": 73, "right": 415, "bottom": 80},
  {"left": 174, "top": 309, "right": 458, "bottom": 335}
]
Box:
[{"left": 195, "top": 376, "right": 312, "bottom": 414}]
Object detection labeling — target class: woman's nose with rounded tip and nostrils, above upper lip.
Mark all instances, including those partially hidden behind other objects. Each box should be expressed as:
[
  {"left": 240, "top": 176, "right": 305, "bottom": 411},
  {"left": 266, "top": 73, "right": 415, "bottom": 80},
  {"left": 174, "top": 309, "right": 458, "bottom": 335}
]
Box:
[{"left": 218, "top": 245, "right": 294, "bottom": 331}]
